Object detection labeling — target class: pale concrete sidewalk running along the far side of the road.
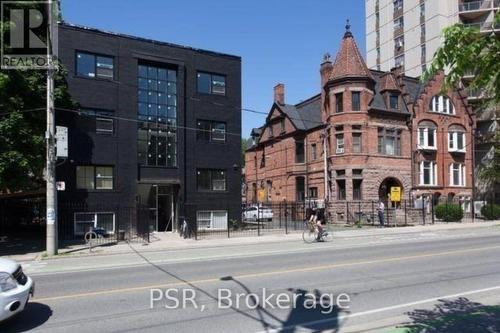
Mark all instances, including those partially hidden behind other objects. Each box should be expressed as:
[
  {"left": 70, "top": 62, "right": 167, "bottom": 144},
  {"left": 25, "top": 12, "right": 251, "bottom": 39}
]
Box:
[{"left": 4, "top": 221, "right": 500, "bottom": 261}]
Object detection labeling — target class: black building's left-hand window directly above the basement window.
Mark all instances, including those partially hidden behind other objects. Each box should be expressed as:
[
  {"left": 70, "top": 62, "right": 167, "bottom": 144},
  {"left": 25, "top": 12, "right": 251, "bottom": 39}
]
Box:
[{"left": 76, "top": 166, "right": 114, "bottom": 190}]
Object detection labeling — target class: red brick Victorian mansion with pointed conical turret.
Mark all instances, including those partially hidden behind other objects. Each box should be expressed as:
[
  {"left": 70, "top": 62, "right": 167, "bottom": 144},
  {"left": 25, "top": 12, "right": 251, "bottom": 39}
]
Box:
[{"left": 245, "top": 26, "right": 474, "bottom": 214}]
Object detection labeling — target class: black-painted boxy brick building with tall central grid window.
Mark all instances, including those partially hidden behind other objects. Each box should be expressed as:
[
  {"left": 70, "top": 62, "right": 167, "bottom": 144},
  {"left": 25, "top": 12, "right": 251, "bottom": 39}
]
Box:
[{"left": 56, "top": 23, "right": 241, "bottom": 235}]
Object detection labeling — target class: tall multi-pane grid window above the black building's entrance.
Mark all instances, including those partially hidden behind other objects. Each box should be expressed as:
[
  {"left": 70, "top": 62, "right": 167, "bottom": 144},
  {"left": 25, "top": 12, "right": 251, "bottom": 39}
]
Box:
[{"left": 137, "top": 64, "right": 177, "bottom": 168}]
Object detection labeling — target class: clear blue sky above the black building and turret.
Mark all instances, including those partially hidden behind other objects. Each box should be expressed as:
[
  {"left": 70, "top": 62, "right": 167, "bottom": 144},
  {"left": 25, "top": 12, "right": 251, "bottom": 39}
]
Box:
[{"left": 62, "top": 0, "right": 365, "bottom": 138}]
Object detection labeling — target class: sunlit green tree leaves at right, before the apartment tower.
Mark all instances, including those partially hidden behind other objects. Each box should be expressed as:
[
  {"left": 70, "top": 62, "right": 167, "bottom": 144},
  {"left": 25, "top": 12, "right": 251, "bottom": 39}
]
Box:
[{"left": 422, "top": 12, "right": 500, "bottom": 184}]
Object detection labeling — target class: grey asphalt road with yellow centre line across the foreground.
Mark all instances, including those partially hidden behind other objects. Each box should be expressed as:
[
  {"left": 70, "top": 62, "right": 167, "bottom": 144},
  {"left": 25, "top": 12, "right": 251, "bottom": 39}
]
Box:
[{"left": 0, "top": 227, "right": 500, "bottom": 333}]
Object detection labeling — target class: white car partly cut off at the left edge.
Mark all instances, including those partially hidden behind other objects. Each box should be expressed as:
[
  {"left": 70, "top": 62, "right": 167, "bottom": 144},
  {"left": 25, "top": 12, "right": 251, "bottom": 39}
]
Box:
[{"left": 0, "top": 259, "right": 35, "bottom": 322}]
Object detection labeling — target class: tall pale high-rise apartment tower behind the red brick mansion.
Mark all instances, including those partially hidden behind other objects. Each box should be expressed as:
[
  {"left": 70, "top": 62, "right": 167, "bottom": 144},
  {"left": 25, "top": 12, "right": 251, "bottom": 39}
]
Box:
[{"left": 365, "top": 0, "right": 500, "bottom": 196}]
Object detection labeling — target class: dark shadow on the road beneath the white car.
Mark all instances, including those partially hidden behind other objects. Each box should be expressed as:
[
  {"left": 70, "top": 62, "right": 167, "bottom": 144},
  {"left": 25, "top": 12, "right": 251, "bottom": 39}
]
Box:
[{"left": 0, "top": 302, "right": 52, "bottom": 333}]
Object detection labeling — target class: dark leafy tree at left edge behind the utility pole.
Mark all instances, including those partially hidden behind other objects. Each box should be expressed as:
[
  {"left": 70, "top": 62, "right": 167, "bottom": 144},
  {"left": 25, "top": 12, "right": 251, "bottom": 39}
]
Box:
[{"left": 0, "top": 66, "right": 76, "bottom": 192}]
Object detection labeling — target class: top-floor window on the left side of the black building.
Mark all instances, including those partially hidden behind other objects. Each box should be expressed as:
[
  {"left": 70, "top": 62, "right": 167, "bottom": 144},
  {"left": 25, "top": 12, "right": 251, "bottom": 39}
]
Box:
[{"left": 76, "top": 52, "right": 114, "bottom": 80}]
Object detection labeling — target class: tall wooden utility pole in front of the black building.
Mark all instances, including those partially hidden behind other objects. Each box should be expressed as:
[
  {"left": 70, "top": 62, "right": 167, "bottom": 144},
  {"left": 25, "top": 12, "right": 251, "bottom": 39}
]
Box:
[{"left": 45, "top": 2, "right": 58, "bottom": 256}]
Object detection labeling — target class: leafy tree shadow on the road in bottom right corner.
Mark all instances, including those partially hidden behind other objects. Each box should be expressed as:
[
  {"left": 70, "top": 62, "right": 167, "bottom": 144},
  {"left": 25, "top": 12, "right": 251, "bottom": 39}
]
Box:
[{"left": 401, "top": 297, "right": 500, "bottom": 333}]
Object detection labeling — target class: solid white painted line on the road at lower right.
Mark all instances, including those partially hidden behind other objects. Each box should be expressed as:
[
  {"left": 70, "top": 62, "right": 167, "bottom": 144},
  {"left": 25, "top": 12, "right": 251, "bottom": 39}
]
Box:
[{"left": 257, "top": 286, "right": 500, "bottom": 333}]
